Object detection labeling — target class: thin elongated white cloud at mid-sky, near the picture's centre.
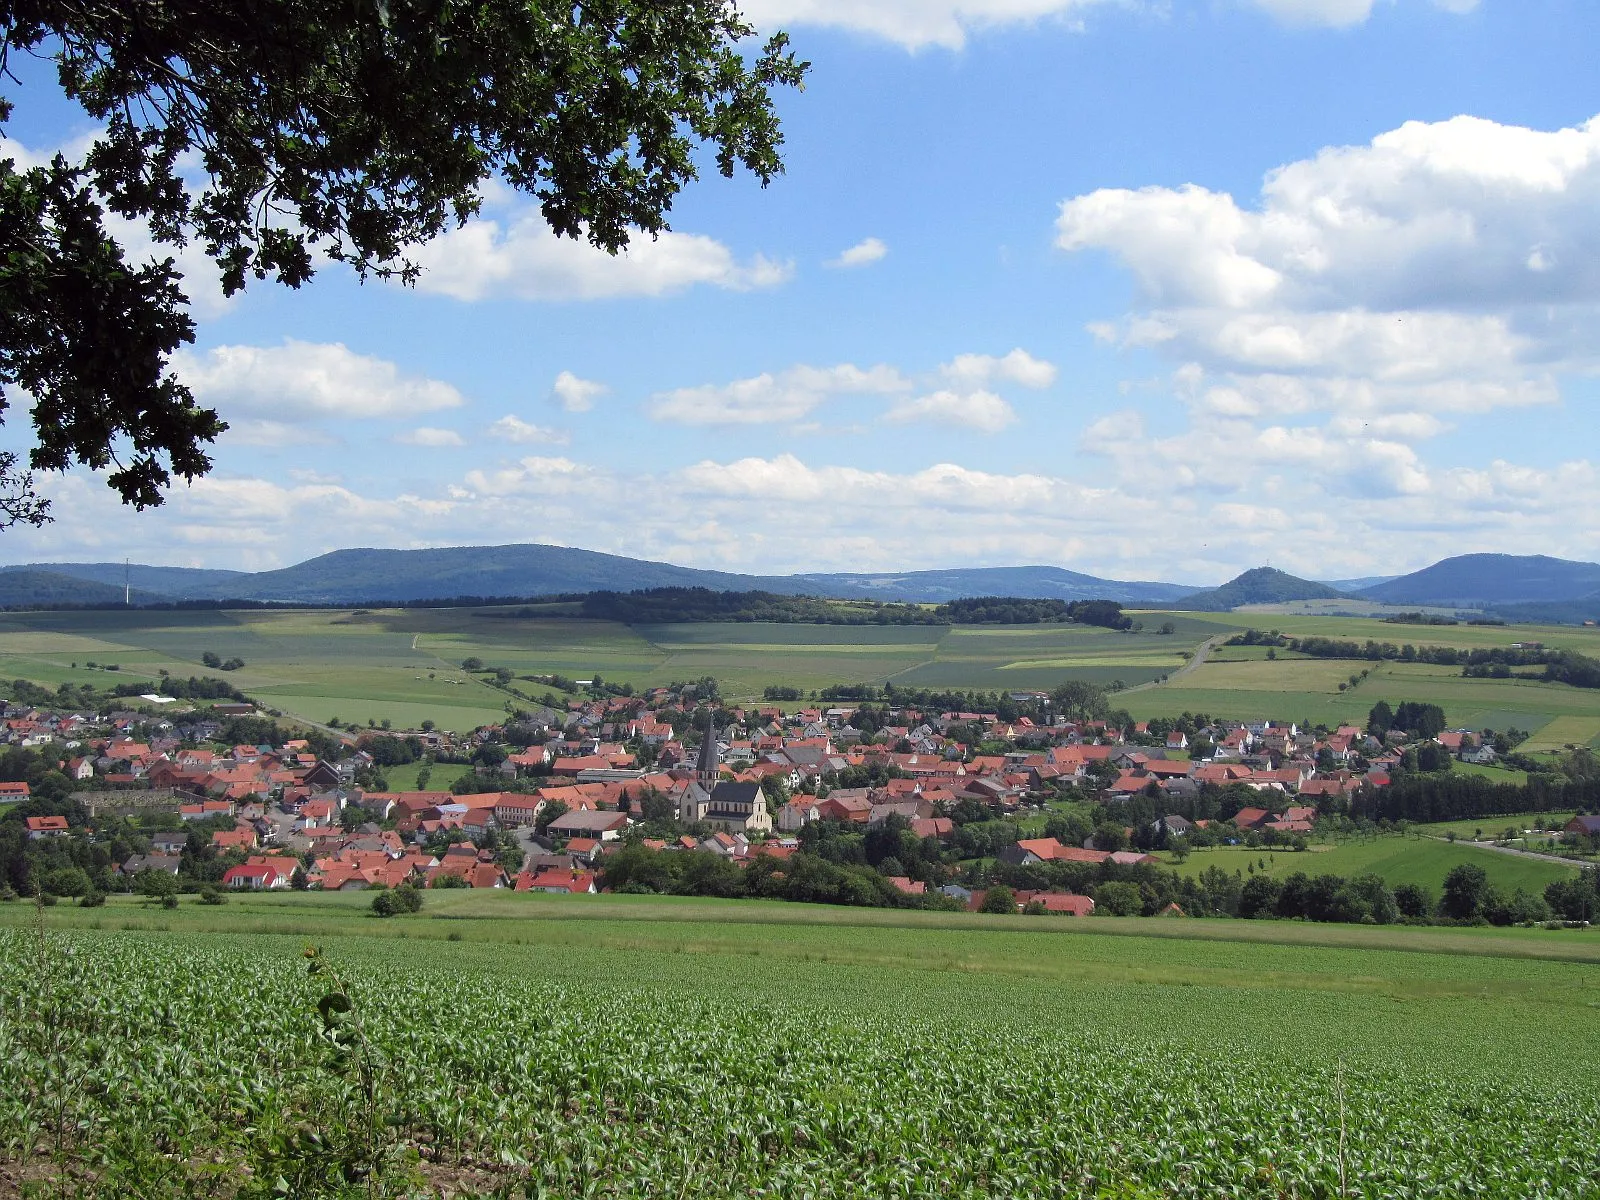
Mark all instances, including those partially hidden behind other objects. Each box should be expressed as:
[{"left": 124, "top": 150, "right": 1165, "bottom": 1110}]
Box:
[{"left": 648, "top": 363, "right": 910, "bottom": 426}]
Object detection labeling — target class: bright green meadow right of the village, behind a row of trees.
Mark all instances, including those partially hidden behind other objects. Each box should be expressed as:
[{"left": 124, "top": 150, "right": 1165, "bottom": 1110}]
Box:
[{"left": 1163, "top": 838, "right": 1576, "bottom": 896}]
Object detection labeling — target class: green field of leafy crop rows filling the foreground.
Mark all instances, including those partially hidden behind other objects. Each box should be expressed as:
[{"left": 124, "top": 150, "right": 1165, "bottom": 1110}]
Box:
[{"left": 0, "top": 917, "right": 1600, "bottom": 1198}]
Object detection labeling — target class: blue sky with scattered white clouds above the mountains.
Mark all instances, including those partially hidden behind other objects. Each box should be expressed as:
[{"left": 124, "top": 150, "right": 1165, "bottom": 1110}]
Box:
[{"left": 0, "top": 0, "right": 1600, "bottom": 582}]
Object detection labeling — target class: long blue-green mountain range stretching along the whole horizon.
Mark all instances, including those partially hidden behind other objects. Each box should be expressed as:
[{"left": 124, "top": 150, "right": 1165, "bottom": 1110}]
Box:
[{"left": 9, "top": 544, "right": 1600, "bottom": 621}]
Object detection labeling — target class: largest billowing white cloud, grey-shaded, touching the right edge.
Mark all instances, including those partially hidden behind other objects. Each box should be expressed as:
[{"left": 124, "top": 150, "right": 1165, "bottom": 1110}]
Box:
[{"left": 1056, "top": 109, "right": 1600, "bottom": 428}]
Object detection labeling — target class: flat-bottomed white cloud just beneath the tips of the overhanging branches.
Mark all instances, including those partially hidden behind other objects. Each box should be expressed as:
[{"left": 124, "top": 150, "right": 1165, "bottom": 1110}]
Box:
[{"left": 413, "top": 205, "right": 794, "bottom": 301}]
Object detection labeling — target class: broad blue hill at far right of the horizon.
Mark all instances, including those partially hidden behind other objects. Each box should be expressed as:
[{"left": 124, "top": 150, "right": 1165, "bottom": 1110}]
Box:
[{"left": 1358, "top": 554, "right": 1600, "bottom": 608}]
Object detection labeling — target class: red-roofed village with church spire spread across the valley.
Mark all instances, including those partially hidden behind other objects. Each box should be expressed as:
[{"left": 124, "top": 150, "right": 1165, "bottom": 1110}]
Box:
[{"left": 0, "top": 686, "right": 1595, "bottom": 915}]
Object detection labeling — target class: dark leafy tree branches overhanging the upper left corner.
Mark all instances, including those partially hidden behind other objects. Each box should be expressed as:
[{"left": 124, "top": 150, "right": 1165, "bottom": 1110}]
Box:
[{"left": 0, "top": 0, "right": 806, "bottom": 528}]
